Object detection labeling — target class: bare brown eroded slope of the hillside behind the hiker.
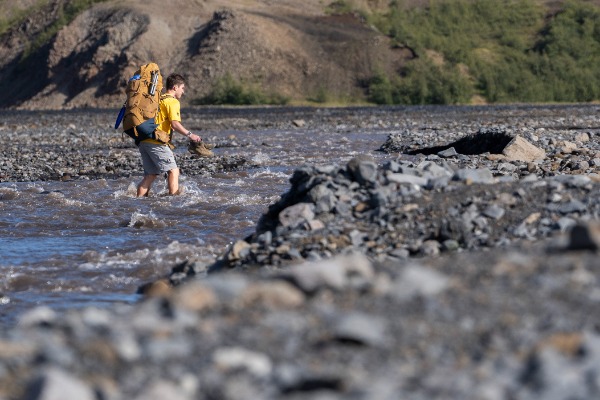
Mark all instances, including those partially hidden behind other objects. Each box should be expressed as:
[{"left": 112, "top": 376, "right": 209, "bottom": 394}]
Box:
[{"left": 0, "top": 0, "right": 402, "bottom": 109}]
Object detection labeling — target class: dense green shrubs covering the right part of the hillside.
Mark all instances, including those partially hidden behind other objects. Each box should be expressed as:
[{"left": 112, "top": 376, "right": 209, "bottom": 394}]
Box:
[{"left": 368, "top": 0, "right": 600, "bottom": 104}]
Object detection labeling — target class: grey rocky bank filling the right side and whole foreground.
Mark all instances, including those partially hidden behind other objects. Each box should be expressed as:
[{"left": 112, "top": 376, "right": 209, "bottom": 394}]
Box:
[{"left": 0, "top": 106, "right": 600, "bottom": 400}]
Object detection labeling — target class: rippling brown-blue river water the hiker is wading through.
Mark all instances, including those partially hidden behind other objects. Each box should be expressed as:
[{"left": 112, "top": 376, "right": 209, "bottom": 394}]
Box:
[{"left": 0, "top": 108, "right": 393, "bottom": 326}]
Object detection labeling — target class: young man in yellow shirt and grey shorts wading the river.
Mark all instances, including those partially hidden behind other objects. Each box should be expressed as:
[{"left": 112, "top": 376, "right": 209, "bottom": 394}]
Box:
[{"left": 137, "top": 74, "right": 202, "bottom": 197}]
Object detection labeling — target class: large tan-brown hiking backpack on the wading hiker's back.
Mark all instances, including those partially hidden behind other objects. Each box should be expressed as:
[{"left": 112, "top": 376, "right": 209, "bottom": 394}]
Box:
[{"left": 115, "top": 62, "right": 164, "bottom": 144}]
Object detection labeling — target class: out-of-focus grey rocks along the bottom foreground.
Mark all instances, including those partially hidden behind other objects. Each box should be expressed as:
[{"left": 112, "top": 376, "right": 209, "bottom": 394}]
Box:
[{"left": 0, "top": 240, "right": 600, "bottom": 400}]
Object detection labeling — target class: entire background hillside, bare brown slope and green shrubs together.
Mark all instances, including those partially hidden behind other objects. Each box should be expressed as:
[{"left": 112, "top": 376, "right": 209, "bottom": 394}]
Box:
[{"left": 0, "top": 0, "right": 600, "bottom": 109}]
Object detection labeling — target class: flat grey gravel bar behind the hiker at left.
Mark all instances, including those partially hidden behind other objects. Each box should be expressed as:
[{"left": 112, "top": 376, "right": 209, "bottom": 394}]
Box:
[{"left": 0, "top": 112, "right": 255, "bottom": 182}]
